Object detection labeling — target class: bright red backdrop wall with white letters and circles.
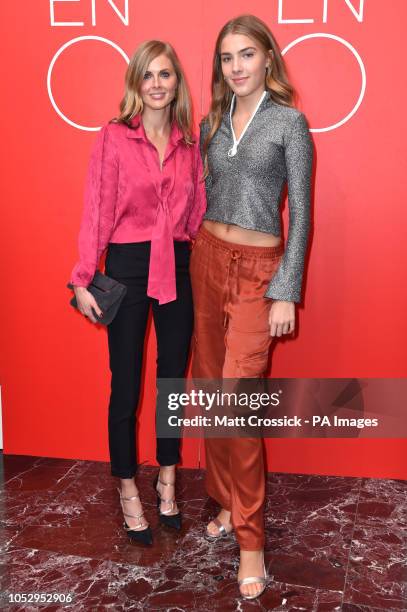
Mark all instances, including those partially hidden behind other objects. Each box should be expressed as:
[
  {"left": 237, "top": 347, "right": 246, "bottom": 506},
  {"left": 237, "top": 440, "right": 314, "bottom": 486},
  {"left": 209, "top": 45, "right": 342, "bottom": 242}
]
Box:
[{"left": 0, "top": 0, "right": 407, "bottom": 478}]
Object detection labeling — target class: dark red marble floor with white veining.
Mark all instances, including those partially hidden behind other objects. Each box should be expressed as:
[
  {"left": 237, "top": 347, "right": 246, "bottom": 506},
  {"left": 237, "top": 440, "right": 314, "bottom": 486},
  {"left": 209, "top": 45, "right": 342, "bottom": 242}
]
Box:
[{"left": 0, "top": 455, "right": 407, "bottom": 612}]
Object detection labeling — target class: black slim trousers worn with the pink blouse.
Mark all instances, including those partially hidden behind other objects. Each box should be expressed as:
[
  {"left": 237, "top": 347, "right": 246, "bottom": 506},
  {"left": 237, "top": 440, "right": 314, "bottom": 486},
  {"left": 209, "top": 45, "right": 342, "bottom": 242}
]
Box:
[{"left": 105, "top": 241, "right": 193, "bottom": 478}]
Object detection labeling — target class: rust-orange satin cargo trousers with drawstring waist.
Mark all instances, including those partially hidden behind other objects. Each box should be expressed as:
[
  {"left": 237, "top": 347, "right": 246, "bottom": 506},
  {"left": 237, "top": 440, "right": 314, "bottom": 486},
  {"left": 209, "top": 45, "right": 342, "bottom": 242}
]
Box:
[{"left": 190, "top": 228, "right": 284, "bottom": 550}]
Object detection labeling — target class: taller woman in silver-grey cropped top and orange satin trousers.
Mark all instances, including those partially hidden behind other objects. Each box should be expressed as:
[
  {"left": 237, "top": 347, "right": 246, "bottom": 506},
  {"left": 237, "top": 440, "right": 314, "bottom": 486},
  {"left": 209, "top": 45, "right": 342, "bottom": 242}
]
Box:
[{"left": 191, "top": 15, "right": 313, "bottom": 598}]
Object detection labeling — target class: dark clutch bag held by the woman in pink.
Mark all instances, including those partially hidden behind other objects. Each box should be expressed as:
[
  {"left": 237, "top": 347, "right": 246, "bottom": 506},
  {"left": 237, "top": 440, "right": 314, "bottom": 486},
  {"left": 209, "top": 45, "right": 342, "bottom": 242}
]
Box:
[{"left": 67, "top": 270, "right": 127, "bottom": 325}]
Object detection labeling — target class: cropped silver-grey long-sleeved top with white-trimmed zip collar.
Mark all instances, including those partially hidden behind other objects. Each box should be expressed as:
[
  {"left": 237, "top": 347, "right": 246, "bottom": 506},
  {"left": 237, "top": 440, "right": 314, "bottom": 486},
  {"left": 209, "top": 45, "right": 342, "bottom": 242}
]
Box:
[{"left": 200, "top": 95, "right": 313, "bottom": 302}]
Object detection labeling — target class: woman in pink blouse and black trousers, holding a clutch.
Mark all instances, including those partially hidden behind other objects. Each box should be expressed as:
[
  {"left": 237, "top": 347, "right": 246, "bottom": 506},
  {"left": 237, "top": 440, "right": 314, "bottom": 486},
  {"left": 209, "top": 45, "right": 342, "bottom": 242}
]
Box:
[{"left": 71, "top": 40, "right": 205, "bottom": 544}]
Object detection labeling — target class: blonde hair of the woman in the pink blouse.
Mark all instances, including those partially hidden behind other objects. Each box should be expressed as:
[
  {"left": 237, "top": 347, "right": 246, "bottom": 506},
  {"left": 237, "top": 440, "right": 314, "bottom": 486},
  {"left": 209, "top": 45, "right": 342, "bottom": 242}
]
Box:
[{"left": 114, "top": 40, "right": 194, "bottom": 144}]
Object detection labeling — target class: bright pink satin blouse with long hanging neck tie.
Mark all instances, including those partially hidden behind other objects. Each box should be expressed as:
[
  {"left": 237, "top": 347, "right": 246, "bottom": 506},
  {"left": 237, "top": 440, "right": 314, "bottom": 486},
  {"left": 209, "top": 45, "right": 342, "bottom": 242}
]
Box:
[{"left": 70, "top": 115, "right": 206, "bottom": 304}]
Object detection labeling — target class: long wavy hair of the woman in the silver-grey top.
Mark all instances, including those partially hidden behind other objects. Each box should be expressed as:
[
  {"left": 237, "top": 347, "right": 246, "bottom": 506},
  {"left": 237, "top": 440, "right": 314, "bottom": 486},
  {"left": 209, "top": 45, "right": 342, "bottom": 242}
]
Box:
[{"left": 202, "top": 15, "right": 295, "bottom": 176}]
